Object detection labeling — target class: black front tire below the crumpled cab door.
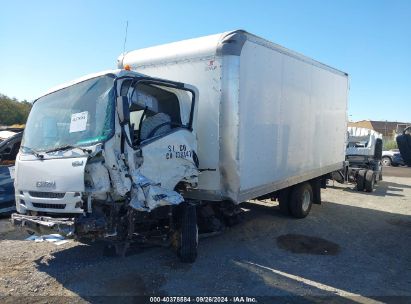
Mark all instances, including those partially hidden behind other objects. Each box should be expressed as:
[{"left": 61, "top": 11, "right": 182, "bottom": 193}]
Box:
[{"left": 178, "top": 203, "right": 198, "bottom": 263}]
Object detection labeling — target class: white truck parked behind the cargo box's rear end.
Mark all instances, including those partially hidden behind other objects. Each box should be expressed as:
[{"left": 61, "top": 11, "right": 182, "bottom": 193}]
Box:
[{"left": 332, "top": 127, "right": 383, "bottom": 192}]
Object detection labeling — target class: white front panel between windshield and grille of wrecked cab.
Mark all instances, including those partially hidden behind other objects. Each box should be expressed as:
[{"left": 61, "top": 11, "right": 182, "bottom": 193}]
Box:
[{"left": 15, "top": 156, "right": 87, "bottom": 192}]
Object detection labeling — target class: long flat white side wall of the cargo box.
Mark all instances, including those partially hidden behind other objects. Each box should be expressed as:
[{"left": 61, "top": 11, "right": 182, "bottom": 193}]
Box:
[{"left": 239, "top": 41, "right": 348, "bottom": 199}]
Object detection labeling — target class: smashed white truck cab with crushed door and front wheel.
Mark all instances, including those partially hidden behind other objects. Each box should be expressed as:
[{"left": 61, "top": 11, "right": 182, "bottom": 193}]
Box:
[{"left": 12, "top": 70, "right": 198, "bottom": 261}]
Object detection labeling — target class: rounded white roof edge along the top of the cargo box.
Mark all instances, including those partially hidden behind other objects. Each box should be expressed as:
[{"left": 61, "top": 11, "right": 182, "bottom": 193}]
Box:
[{"left": 117, "top": 30, "right": 348, "bottom": 76}]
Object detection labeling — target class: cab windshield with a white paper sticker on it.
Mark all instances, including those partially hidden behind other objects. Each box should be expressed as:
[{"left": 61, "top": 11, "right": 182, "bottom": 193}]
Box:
[{"left": 22, "top": 75, "right": 115, "bottom": 153}]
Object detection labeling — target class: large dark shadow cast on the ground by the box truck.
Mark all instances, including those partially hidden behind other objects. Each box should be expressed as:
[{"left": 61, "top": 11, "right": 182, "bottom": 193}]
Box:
[{"left": 32, "top": 196, "right": 411, "bottom": 302}]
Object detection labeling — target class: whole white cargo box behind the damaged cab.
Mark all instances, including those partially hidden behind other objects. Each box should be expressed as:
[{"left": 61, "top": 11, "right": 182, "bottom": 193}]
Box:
[{"left": 119, "top": 31, "right": 348, "bottom": 203}]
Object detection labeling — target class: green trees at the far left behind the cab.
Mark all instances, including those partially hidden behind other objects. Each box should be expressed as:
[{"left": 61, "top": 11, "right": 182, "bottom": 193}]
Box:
[{"left": 0, "top": 94, "right": 32, "bottom": 126}]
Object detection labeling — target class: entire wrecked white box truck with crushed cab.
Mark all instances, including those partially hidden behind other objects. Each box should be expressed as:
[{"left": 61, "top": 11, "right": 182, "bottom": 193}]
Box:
[{"left": 12, "top": 30, "right": 348, "bottom": 262}]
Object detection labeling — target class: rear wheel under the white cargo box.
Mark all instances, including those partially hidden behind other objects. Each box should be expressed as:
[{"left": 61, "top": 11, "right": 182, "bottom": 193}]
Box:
[{"left": 290, "top": 182, "right": 313, "bottom": 218}]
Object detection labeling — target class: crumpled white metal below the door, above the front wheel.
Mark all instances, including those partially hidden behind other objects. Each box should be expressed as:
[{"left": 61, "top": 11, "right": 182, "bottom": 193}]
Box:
[{"left": 130, "top": 173, "right": 184, "bottom": 211}]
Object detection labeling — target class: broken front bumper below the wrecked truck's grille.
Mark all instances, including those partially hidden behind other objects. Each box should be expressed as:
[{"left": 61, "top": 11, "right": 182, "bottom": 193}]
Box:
[{"left": 11, "top": 213, "right": 74, "bottom": 237}]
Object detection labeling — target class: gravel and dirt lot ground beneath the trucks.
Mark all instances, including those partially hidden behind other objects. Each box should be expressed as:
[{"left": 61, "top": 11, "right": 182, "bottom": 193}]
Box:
[{"left": 0, "top": 168, "right": 411, "bottom": 303}]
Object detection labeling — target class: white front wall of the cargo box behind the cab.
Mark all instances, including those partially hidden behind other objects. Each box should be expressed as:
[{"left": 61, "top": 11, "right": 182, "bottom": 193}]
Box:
[{"left": 132, "top": 58, "right": 221, "bottom": 196}]
